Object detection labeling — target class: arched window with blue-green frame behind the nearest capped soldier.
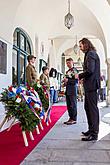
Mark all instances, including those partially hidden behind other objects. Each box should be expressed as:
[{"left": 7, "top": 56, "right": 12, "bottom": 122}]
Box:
[{"left": 12, "top": 28, "right": 31, "bottom": 85}]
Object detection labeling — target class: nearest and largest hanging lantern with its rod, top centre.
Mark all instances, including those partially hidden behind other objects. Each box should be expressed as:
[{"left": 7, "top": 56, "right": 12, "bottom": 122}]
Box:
[{"left": 64, "top": 0, "right": 74, "bottom": 29}]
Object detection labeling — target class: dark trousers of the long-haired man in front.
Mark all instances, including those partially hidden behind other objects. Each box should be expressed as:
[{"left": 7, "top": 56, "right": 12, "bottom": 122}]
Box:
[{"left": 84, "top": 91, "right": 99, "bottom": 136}]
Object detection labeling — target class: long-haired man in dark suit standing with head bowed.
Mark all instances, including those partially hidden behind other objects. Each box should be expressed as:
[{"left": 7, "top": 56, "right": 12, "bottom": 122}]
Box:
[{"left": 79, "top": 38, "right": 100, "bottom": 141}]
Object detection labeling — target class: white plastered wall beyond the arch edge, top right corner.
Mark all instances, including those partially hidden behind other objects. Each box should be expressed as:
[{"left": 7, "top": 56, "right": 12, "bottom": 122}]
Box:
[{"left": 80, "top": 0, "right": 110, "bottom": 58}]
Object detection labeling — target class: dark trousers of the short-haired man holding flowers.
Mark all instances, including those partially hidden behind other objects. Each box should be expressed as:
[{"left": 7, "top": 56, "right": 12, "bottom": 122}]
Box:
[{"left": 66, "top": 88, "right": 77, "bottom": 121}]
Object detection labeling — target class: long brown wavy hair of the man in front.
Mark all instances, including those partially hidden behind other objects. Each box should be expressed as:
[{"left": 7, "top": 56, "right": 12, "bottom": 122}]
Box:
[{"left": 79, "top": 38, "right": 96, "bottom": 51}]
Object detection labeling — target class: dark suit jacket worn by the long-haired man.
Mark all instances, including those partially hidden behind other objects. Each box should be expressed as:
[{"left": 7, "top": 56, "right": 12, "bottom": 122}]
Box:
[{"left": 79, "top": 51, "right": 100, "bottom": 92}]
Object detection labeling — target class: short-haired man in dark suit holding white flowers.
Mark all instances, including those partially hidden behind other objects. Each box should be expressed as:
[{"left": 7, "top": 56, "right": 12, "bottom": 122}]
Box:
[{"left": 63, "top": 58, "right": 78, "bottom": 125}]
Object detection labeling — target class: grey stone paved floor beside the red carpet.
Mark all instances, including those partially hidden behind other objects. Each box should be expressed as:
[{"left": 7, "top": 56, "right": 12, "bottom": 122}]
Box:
[{"left": 21, "top": 102, "right": 110, "bottom": 165}]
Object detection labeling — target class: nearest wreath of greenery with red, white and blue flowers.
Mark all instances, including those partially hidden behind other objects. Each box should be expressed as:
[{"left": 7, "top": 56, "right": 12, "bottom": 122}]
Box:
[{"left": 0, "top": 86, "right": 43, "bottom": 131}]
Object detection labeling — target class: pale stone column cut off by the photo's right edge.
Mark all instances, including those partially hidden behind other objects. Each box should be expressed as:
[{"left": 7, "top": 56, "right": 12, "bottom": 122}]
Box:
[{"left": 106, "top": 58, "right": 110, "bottom": 105}]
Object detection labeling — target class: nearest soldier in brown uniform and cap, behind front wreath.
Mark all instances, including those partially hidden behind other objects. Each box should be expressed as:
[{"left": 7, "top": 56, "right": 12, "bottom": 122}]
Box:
[{"left": 26, "top": 55, "right": 37, "bottom": 86}]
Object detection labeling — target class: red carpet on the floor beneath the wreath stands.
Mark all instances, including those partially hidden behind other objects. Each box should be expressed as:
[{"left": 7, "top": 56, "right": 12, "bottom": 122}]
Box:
[{"left": 0, "top": 106, "right": 66, "bottom": 165}]
